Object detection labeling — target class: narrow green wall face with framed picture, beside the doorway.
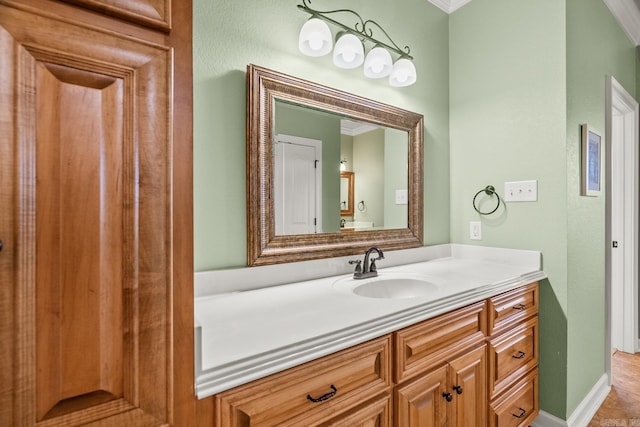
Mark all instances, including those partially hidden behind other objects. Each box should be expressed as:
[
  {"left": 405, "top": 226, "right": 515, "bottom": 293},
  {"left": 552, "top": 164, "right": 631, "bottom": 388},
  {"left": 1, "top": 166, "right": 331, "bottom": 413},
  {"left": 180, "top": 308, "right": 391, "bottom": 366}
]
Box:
[{"left": 566, "top": 0, "right": 636, "bottom": 415}]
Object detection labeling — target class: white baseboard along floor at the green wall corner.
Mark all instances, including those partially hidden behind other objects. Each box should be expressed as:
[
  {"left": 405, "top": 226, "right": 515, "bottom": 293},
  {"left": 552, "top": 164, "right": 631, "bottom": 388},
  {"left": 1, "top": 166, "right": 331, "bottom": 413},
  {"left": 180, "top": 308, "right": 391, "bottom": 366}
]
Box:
[{"left": 532, "top": 374, "right": 611, "bottom": 427}]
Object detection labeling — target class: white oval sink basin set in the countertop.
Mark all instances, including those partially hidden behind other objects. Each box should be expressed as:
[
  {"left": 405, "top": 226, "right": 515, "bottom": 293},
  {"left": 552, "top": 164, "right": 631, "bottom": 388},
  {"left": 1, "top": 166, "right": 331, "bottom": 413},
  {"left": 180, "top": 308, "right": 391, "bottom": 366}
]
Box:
[{"left": 352, "top": 277, "right": 439, "bottom": 299}]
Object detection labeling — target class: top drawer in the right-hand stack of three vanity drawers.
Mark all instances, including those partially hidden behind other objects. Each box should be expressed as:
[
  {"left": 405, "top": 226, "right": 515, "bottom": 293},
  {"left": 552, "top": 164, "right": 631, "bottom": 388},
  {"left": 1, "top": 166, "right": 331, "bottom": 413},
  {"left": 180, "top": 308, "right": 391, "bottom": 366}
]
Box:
[{"left": 489, "top": 282, "right": 538, "bottom": 335}]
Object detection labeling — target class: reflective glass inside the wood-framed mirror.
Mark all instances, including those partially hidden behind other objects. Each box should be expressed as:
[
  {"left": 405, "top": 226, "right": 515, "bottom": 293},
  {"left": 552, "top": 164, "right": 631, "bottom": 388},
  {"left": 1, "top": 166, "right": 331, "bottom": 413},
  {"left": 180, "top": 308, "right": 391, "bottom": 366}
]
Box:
[{"left": 273, "top": 98, "right": 408, "bottom": 235}]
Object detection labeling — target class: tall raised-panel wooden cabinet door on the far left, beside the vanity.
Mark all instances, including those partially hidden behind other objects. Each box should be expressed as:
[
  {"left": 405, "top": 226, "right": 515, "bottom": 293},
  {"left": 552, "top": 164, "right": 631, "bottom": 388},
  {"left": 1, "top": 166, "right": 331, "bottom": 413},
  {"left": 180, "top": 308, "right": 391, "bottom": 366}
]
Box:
[{"left": 0, "top": 0, "right": 193, "bottom": 426}]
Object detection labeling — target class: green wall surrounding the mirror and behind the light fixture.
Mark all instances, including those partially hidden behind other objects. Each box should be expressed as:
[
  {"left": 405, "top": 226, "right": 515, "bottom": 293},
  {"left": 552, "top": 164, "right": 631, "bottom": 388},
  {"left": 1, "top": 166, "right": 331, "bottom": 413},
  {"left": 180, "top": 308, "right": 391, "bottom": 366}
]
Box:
[{"left": 193, "top": 0, "right": 450, "bottom": 271}]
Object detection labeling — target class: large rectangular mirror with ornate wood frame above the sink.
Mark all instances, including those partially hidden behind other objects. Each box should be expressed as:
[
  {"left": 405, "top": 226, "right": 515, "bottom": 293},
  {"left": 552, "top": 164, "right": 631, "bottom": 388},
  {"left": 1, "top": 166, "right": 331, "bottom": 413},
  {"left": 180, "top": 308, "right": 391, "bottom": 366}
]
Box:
[{"left": 246, "top": 65, "right": 424, "bottom": 266}]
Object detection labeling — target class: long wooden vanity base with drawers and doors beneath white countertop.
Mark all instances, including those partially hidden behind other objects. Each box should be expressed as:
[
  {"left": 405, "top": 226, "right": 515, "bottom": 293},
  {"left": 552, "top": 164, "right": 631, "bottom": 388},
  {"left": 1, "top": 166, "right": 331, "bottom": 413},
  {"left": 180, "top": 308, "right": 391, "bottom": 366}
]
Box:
[{"left": 199, "top": 283, "right": 538, "bottom": 427}]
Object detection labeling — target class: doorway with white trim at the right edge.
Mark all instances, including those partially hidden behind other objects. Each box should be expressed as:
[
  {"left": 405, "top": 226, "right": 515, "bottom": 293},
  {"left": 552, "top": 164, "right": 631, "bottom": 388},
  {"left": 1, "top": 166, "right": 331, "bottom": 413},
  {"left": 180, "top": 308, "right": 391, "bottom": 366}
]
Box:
[{"left": 605, "top": 76, "right": 640, "bottom": 383}]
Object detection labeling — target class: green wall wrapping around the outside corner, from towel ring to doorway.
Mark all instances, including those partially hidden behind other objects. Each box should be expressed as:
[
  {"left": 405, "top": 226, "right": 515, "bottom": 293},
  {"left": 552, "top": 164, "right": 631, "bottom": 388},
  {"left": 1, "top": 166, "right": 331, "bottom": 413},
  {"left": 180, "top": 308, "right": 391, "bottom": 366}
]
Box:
[{"left": 450, "top": 0, "right": 638, "bottom": 419}]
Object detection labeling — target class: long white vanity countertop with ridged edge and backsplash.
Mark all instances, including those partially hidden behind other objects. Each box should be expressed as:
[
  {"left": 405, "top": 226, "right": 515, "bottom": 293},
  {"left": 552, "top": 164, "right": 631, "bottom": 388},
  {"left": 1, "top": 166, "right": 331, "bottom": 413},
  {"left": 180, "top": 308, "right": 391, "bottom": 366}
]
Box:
[{"left": 195, "top": 245, "right": 546, "bottom": 398}]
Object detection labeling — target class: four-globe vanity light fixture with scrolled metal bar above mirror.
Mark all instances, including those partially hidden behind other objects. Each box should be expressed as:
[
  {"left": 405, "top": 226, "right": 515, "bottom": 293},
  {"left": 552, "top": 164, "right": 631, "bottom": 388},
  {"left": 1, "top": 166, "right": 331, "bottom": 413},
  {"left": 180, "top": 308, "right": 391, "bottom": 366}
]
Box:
[{"left": 298, "top": 0, "right": 417, "bottom": 87}]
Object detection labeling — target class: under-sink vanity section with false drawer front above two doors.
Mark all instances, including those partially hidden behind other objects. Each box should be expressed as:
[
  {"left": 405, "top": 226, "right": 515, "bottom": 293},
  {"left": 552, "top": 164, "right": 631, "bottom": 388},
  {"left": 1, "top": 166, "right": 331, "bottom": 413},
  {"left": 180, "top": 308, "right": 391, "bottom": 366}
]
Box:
[{"left": 394, "top": 301, "right": 487, "bottom": 427}]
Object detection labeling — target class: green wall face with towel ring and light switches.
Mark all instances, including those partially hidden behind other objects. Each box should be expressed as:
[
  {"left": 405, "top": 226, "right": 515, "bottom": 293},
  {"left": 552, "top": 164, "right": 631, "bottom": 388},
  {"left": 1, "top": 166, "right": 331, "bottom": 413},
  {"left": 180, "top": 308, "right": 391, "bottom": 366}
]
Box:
[{"left": 449, "top": 0, "right": 567, "bottom": 417}]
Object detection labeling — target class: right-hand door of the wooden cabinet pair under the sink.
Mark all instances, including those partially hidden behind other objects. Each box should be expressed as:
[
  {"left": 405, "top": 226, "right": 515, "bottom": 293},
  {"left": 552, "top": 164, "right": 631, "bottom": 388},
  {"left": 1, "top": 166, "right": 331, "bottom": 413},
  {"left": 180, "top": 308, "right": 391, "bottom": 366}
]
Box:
[{"left": 447, "top": 345, "right": 488, "bottom": 427}]
